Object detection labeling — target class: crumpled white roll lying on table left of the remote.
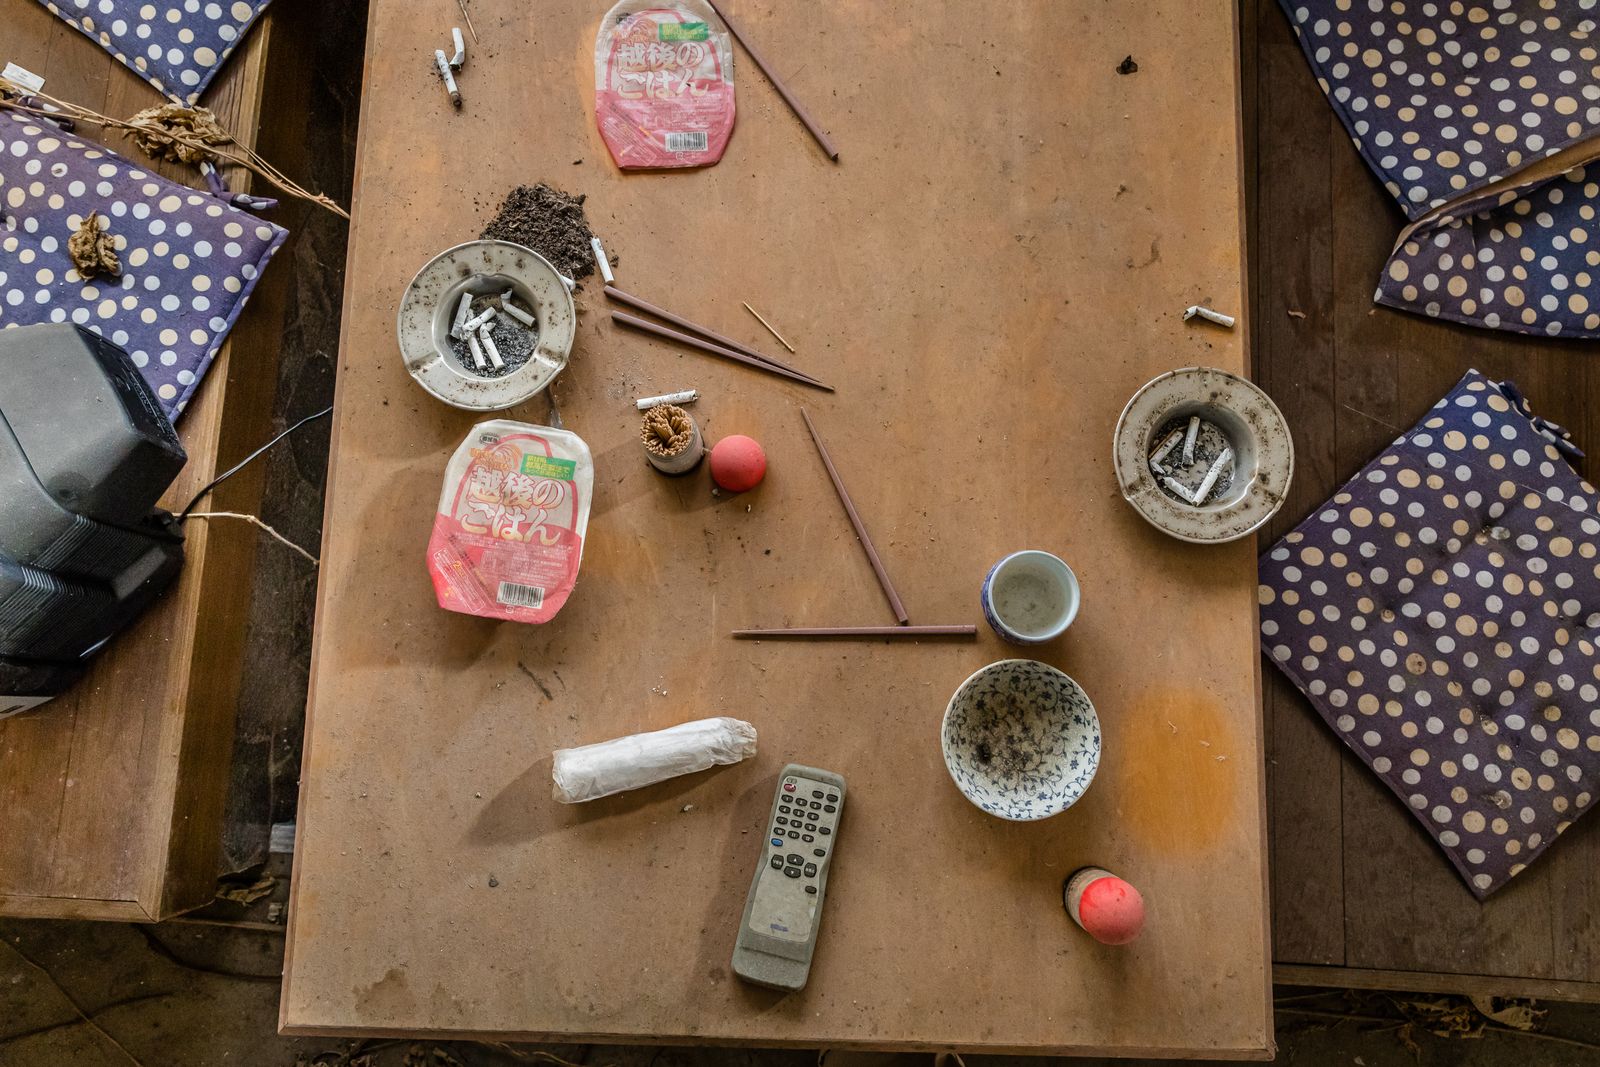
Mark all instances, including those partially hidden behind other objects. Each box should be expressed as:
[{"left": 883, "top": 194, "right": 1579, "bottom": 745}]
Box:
[{"left": 550, "top": 718, "right": 755, "bottom": 805}]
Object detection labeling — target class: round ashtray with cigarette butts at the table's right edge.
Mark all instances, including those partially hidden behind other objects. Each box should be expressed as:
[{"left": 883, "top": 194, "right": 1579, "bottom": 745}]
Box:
[{"left": 1114, "top": 366, "right": 1294, "bottom": 544}]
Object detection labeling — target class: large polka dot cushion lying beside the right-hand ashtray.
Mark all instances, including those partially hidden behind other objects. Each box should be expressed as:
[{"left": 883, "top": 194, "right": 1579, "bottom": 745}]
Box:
[{"left": 1261, "top": 371, "right": 1600, "bottom": 897}]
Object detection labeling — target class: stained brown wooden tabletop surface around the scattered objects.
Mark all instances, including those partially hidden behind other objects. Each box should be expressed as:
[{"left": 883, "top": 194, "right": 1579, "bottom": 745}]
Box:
[{"left": 282, "top": 0, "right": 1272, "bottom": 1057}]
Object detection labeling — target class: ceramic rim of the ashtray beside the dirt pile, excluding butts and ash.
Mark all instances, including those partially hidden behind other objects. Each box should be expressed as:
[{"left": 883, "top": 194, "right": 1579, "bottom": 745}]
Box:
[{"left": 395, "top": 242, "right": 578, "bottom": 411}]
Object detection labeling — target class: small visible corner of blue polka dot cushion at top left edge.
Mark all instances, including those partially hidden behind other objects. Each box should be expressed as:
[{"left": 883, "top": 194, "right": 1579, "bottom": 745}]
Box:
[{"left": 40, "top": 0, "right": 269, "bottom": 104}]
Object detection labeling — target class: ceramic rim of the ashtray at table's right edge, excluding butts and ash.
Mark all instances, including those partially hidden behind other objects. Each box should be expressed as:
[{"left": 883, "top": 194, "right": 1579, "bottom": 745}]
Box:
[{"left": 1112, "top": 366, "right": 1294, "bottom": 544}]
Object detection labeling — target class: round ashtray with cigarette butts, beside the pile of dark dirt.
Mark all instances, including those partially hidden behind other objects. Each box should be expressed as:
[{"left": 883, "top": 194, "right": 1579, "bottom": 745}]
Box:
[{"left": 397, "top": 242, "right": 578, "bottom": 411}]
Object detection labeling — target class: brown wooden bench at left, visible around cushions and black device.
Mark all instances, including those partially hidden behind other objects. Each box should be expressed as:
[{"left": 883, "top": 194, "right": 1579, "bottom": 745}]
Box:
[{"left": 0, "top": 0, "right": 283, "bottom": 921}]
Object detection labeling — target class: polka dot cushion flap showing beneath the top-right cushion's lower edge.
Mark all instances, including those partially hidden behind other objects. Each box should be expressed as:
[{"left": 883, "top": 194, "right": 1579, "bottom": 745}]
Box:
[{"left": 1374, "top": 166, "right": 1600, "bottom": 338}]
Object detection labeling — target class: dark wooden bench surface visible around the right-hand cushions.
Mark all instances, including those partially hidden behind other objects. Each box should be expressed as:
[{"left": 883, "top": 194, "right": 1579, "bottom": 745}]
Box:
[{"left": 1242, "top": 0, "right": 1600, "bottom": 1000}]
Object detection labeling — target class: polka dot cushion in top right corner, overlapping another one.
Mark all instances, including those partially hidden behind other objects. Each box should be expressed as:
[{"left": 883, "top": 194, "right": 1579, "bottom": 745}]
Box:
[{"left": 1282, "top": 0, "right": 1600, "bottom": 219}]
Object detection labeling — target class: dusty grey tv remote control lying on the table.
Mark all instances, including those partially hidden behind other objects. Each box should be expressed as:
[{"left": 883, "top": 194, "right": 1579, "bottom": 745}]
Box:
[{"left": 733, "top": 763, "right": 845, "bottom": 990}]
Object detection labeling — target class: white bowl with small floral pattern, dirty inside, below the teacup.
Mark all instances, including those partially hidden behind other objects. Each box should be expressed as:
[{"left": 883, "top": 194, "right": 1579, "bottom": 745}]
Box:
[{"left": 941, "top": 659, "right": 1101, "bottom": 822}]
